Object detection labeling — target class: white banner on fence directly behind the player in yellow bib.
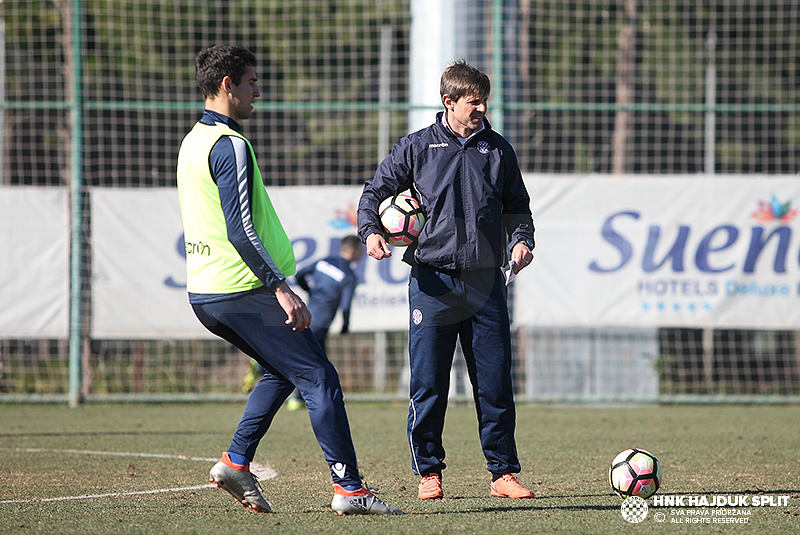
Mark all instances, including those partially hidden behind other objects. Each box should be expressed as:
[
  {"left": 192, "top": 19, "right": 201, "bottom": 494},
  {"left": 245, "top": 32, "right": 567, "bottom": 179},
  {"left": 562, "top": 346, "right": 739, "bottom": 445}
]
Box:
[{"left": 92, "top": 186, "right": 409, "bottom": 339}]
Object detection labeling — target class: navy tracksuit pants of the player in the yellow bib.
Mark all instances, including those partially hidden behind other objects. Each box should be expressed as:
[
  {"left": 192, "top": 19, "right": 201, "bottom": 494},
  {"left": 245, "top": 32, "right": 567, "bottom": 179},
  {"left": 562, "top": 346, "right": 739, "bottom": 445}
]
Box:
[{"left": 192, "top": 291, "right": 361, "bottom": 486}]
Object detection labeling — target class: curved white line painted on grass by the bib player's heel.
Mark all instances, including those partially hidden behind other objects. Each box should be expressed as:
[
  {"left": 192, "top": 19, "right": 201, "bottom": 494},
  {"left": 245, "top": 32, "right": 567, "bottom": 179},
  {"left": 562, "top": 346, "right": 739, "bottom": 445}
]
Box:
[{"left": 0, "top": 448, "right": 278, "bottom": 504}]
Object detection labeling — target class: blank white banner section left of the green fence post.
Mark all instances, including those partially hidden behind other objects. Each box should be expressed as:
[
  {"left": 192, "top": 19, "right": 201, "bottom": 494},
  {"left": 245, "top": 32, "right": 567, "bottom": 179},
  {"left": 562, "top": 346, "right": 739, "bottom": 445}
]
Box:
[{"left": 0, "top": 187, "right": 69, "bottom": 339}]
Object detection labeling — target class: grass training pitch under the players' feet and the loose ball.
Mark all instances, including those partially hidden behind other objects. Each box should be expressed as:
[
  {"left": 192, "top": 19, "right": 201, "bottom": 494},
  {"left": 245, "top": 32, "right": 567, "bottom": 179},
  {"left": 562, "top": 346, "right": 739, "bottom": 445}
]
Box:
[{"left": 0, "top": 403, "right": 800, "bottom": 535}]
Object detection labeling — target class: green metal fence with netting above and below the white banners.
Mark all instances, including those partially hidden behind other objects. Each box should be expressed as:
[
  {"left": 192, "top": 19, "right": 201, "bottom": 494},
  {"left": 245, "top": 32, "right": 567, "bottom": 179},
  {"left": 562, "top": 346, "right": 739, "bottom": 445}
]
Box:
[{"left": 0, "top": 0, "right": 800, "bottom": 405}]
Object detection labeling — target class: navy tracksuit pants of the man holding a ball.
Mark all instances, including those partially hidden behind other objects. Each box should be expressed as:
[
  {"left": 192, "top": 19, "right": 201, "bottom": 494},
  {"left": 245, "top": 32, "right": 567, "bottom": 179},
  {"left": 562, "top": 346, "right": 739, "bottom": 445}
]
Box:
[{"left": 408, "top": 265, "right": 520, "bottom": 475}]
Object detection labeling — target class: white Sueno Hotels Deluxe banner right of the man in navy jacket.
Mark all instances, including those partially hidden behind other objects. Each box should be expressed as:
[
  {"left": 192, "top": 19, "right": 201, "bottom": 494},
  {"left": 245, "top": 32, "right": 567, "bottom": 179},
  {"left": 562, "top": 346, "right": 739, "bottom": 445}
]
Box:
[{"left": 513, "top": 175, "right": 800, "bottom": 329}]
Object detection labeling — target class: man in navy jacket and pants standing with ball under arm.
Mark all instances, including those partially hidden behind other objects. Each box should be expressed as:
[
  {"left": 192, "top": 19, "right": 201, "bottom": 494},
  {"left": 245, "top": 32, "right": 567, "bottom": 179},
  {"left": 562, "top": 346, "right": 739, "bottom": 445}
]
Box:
[{"left": 358, "top": 61, "right": 534, "bottom": 499}]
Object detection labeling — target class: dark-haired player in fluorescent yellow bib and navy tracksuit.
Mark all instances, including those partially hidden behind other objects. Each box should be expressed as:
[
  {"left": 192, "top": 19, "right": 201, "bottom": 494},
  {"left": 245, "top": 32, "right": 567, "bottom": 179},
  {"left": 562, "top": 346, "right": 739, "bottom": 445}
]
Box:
[{"left": 177, "top": 45, "right": 402, "bottom": 515}]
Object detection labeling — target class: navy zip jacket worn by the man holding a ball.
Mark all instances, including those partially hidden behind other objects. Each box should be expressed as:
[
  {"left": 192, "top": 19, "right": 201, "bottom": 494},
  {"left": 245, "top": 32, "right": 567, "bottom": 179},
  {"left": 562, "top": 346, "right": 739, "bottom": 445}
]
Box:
[{"left": 358, "top": 112, "right": 533, "bottom": 269}]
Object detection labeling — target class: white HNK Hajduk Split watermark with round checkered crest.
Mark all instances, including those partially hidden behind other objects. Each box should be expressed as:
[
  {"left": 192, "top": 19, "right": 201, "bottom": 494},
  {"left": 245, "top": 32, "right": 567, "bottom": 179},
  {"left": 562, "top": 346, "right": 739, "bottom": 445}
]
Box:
[{"left": 620, "top": 494, "right": 789, "bottom": 524}]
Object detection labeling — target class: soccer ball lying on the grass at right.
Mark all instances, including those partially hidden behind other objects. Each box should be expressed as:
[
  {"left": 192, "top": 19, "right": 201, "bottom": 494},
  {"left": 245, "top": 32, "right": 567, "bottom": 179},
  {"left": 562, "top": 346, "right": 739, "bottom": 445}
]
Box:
[{"left": 608, "top": 448, "right": 661, "bottom": 498}]
